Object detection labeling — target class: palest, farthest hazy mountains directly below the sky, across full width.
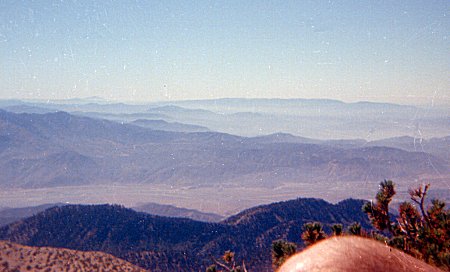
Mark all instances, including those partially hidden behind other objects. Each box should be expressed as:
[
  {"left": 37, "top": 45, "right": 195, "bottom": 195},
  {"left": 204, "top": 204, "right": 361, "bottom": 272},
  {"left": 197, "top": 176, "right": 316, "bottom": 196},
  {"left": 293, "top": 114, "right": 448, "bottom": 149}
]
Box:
[{"left": 0, "top": 97, "right": 450, "bottom": 141}]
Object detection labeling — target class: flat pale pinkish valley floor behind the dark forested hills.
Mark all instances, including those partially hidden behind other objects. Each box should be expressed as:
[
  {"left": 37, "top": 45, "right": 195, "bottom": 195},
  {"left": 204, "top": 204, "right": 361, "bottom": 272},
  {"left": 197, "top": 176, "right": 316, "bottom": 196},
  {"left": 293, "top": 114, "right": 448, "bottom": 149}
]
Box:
[{"left": 0, "top": 178, "right": 450, "bottom": 216}]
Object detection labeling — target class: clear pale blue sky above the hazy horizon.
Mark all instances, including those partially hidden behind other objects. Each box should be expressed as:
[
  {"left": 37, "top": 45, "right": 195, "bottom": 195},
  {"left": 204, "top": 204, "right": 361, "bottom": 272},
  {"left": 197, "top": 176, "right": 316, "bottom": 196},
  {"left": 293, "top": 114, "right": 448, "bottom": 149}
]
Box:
[{"left": 0, "top": 0, "right": 450, "bottom": 104}]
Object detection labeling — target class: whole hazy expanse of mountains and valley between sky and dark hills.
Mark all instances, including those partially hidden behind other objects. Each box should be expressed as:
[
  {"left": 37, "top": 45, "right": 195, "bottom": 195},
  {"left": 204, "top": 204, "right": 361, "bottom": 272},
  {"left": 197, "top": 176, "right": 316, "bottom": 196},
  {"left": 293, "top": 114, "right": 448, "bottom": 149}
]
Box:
[{"left": 0, "top": 98, "right": 450, "bottom": 215}]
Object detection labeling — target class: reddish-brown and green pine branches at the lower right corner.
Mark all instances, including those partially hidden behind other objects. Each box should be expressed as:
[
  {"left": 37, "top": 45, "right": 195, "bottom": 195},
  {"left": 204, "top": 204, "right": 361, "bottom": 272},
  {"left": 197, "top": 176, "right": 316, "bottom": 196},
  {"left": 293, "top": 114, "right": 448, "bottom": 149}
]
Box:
[{"left": 363, "top": 181, "right": 450, "bottom": 270}]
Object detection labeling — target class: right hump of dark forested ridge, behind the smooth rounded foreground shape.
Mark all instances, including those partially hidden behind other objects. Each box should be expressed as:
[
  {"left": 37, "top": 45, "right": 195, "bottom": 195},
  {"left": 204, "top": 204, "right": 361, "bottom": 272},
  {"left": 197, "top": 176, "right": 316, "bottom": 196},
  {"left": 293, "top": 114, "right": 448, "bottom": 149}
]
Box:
[{"left": 216, "top": 198, "right": 371, "bottom": 271}]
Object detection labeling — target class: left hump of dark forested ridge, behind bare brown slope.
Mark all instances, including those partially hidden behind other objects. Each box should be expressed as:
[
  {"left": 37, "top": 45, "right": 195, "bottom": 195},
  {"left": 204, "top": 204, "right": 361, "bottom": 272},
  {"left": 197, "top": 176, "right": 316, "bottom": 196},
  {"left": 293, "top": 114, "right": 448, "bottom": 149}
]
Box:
[{"left": 0, "top": 205, "right": 227, "bottom": 271}]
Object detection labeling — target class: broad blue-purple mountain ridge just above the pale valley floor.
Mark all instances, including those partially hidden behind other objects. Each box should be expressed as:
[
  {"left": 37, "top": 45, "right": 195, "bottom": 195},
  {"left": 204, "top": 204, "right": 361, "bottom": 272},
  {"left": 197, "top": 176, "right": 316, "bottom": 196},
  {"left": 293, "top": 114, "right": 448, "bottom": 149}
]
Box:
[{"left": 0, "top": 110, "right": 450, "bottom": 188}]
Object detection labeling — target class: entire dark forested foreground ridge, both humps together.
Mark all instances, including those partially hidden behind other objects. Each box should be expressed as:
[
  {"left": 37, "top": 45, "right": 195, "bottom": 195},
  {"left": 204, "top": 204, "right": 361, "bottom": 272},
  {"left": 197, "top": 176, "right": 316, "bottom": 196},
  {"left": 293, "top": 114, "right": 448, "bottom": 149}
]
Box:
[{"left": 0, "top": 199, "right": 369, "bottom": 271}]
